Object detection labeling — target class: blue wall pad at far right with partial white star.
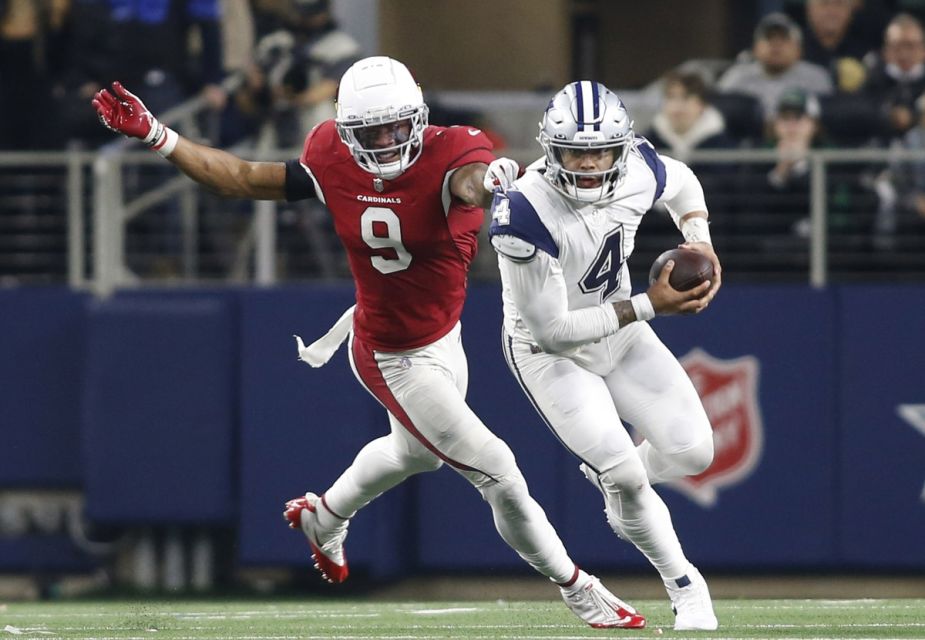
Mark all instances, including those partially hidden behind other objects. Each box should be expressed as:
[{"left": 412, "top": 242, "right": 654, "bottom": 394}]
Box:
[{"left": 833, "top": 286, "right": 925, "bottom": 569}]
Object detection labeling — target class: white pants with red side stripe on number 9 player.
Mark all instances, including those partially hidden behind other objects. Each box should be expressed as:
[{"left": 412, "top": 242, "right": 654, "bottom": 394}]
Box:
[{"left": 324, "top": 323, "right": 576, "bottom": 583}]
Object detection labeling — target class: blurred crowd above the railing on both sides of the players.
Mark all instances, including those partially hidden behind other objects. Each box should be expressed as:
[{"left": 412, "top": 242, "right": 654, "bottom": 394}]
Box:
[{"left": 0, "top": 0, "right": 925, "bottom": 152}]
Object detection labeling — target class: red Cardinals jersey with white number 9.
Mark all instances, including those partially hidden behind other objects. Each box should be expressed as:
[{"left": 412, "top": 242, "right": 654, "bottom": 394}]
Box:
[{"left": 301, "top": 120, "right": 494, "bottom": 351}]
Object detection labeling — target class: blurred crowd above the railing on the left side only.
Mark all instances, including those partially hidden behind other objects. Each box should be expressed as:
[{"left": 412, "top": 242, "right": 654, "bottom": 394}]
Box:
[{"left": 0, "top": 0, "right": 360, "bottom": 150}]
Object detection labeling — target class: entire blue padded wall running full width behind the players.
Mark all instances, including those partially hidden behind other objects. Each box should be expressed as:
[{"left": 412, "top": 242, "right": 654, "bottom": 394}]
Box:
[{"left": 0, "top": 284, "right": 925, "bottom": 577}]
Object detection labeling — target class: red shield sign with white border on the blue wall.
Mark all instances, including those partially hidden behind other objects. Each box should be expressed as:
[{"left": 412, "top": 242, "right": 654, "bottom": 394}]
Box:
[{"left": 671, "top": 349, "right": 764, "bottom": 506}]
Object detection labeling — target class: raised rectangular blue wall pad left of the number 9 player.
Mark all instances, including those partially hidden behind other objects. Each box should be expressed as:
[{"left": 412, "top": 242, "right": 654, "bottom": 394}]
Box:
[{"left": 83, "top": 294, "right": 237, "bottom": 524}]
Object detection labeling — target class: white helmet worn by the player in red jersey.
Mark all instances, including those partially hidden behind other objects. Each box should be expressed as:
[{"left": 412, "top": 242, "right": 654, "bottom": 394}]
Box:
[{"left": 334, "top": 56, "right": 427, "bottom": 180}]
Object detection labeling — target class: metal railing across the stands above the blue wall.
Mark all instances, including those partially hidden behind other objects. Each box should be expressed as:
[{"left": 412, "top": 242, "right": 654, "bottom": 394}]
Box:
[{"left": 0, "top": 144, "right": 925, "bottom": 295}]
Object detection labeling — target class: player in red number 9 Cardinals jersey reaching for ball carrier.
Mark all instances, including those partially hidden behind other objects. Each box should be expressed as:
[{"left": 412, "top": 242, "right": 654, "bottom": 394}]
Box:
[{"left": 93, "top": 56, "right": 645, "bottom": 628}]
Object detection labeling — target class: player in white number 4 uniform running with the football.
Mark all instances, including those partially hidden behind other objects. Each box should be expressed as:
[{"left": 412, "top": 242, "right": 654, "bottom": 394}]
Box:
[{"left": 489, "top": 81, "right": 721, "bottom": 630}]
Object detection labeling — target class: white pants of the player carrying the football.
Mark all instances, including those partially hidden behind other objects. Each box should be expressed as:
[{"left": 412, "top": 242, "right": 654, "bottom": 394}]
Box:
[{"left": 503, "top": 322, "right": 713, "bottom": 579}]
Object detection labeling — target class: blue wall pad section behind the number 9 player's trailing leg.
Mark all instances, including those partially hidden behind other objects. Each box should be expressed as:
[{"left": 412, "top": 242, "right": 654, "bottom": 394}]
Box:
[{"left": 233, "top": 285, "right": 408, "bottom": 575}]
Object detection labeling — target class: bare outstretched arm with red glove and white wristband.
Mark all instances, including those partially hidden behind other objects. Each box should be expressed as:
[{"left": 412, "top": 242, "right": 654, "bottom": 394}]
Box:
[{"left": 93, "top": 82, "right": 286, "bottom": 200}]
